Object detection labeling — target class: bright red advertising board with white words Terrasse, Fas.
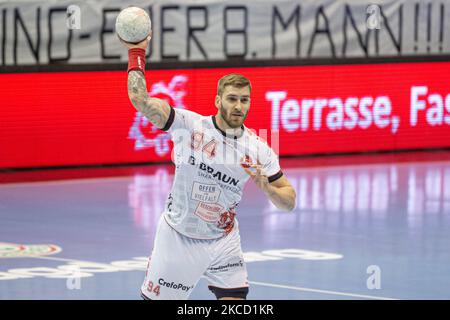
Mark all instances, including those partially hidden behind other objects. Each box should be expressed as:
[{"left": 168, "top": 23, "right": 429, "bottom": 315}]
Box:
[{"left": 0, "top": 62, "right": 450, "bottom": 168}]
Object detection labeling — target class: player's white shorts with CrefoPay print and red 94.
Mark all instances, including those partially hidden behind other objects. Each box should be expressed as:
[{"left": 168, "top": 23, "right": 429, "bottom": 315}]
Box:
[{"left": 141, "top": 216, "right": 248, "bottom": 300}]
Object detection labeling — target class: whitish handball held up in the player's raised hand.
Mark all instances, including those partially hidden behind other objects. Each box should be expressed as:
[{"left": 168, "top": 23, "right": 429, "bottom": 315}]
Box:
[{"left": 116, "top": 7, "right": 152, "bottom": 43}]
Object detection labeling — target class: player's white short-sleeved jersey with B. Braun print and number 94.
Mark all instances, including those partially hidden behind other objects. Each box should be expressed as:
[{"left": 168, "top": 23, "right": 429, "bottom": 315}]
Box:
[{"left": 163, "top": 108, "right": 282, "bottom": 239}]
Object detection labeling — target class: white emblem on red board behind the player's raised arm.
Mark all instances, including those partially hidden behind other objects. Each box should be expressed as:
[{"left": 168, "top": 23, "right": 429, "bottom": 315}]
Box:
[{"left": 128, "top": 75, "right": 188, "bottom": 157}]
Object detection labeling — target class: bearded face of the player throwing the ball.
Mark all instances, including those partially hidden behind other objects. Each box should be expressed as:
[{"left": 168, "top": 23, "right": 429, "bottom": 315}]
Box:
[{"left": 216, "top": 86, "right": 250, "bottom": 129}]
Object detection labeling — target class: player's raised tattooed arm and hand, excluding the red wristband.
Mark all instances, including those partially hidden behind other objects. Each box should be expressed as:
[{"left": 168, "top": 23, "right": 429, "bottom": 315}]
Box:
[{"left": 119, "top": 33, "right": 170, "bottom": 129}]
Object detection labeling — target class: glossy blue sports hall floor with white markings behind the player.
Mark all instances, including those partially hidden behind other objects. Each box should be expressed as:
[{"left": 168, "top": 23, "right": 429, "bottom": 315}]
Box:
[{"left": 0, "top": 151, "right": 450, "bottom": 299}]
